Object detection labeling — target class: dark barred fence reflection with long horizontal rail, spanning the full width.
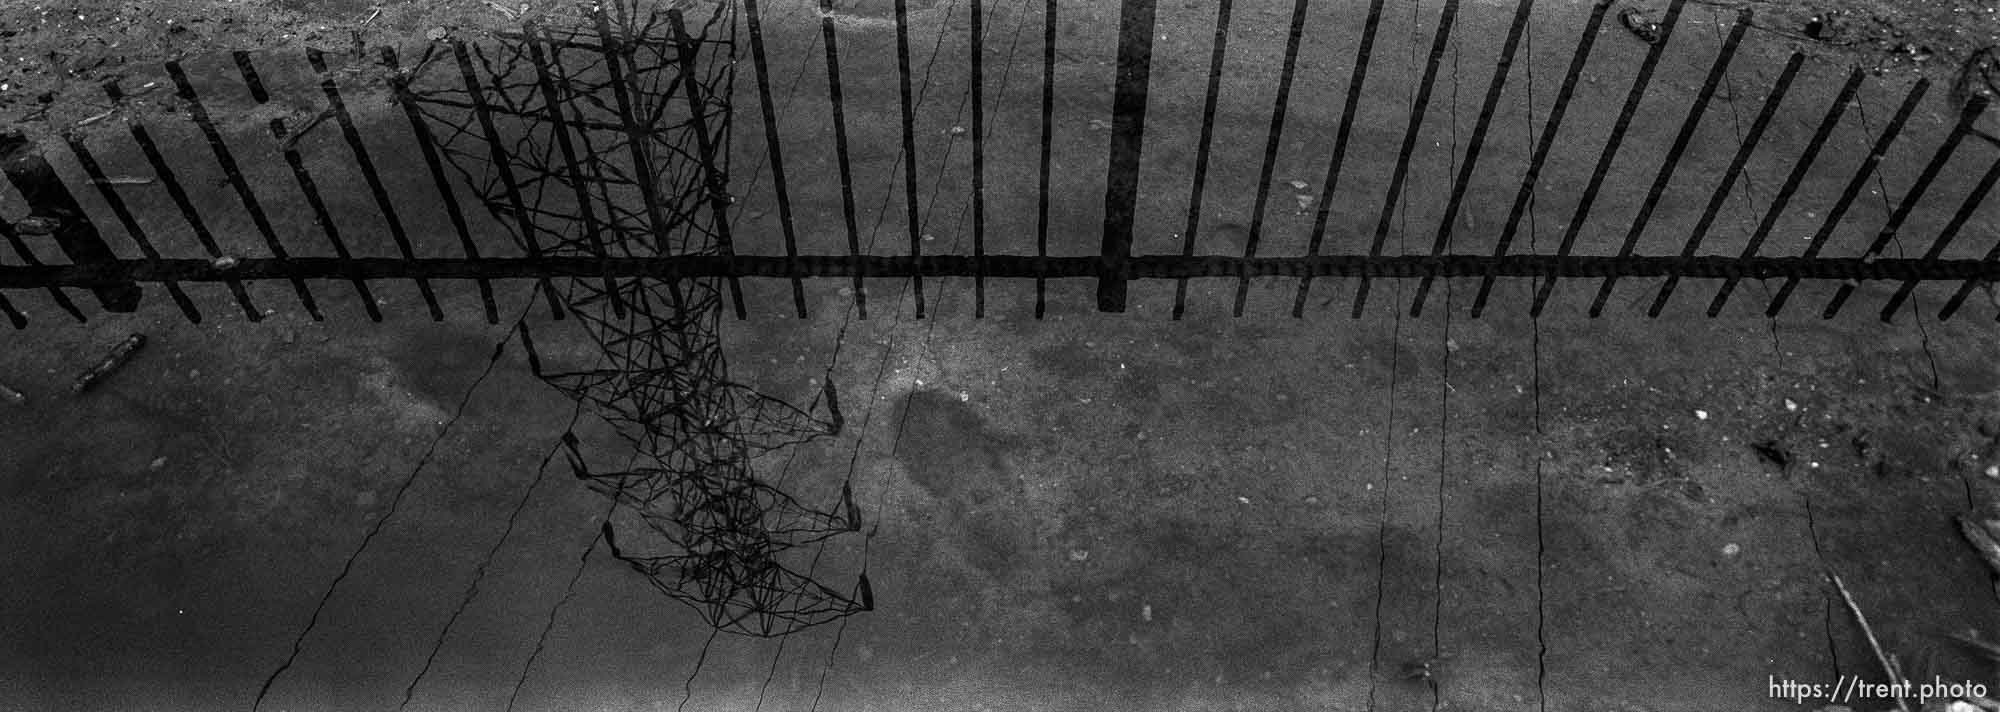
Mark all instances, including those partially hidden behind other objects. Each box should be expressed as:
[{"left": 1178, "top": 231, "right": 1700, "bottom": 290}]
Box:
[{"left": 0, "top": 0, "right": 2000, "bottom": 328}]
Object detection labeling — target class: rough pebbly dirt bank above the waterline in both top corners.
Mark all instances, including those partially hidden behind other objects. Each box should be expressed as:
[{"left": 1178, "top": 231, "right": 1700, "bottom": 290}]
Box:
[{"left": 0, "top": 0, "right": 2000, "bottom": 120}]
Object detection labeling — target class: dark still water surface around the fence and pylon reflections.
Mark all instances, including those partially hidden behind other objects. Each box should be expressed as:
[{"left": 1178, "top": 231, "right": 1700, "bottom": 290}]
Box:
[{"left": 0, "top": 2, "right": 2000, "bottom": 710}]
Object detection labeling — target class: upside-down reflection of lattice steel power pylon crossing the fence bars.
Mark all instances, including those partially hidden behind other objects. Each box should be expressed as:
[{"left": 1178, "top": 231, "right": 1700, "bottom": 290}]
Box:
[{"left": 398, "top": 4, "right": 872, "bottom": 636}]
